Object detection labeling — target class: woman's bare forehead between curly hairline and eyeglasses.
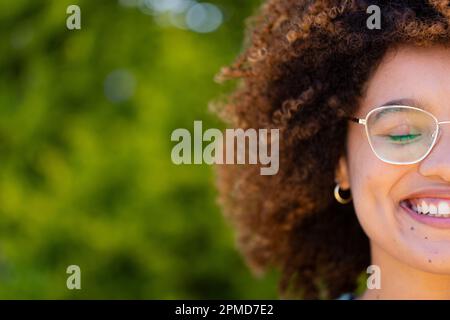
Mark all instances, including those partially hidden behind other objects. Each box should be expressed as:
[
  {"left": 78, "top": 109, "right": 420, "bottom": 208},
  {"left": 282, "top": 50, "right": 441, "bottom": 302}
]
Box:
[{"left": 358, "top": 46, "right": 450, "bottom": 115}]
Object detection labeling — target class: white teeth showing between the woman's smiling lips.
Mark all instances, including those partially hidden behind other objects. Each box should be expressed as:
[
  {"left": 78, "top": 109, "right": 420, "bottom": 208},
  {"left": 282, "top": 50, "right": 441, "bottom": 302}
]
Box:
[{"left": 400, "top": 198, "right": 450, "bottom": 218}]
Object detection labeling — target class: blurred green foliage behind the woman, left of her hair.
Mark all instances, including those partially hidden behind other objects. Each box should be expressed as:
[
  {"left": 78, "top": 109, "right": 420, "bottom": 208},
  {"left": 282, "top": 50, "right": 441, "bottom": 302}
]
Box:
[{"left": 0, "top": 0, "right": 278, "bottom": 299}]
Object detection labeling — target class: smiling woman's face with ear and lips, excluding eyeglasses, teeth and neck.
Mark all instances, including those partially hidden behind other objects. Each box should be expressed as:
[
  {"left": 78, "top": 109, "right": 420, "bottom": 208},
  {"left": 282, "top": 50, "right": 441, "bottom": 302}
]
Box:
[{"left": 337, "top": 46, "right": 450, "bottom": 274}]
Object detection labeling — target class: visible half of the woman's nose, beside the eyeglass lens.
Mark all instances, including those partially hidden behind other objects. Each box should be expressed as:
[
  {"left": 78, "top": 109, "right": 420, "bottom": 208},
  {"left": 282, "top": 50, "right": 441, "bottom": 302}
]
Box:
[{"left": 419, "top": 121, "right": 450, "bottom": 182}]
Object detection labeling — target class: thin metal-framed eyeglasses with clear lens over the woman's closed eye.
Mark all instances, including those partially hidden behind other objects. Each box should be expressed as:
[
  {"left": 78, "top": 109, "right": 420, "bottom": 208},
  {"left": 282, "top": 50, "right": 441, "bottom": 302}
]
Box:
[{"left": 349, "top": 105, "right": 450, "bottom": 164}]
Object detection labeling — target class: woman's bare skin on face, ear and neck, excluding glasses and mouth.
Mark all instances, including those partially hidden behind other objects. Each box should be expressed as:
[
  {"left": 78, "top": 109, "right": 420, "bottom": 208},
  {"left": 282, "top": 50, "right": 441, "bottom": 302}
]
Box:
[{"left": 336, "top": 46, "right": 450, "bottom": 299}]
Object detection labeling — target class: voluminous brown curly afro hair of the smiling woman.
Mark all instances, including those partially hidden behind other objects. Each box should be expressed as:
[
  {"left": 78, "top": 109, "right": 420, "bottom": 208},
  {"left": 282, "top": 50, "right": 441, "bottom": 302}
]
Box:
[{"left": 213, "top": 0, "right": 450, "bottom": 299}]
